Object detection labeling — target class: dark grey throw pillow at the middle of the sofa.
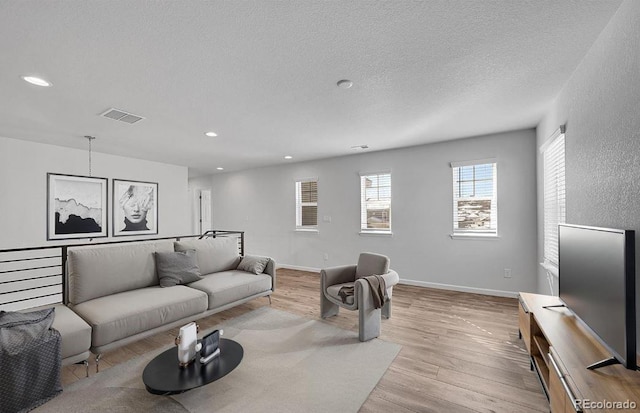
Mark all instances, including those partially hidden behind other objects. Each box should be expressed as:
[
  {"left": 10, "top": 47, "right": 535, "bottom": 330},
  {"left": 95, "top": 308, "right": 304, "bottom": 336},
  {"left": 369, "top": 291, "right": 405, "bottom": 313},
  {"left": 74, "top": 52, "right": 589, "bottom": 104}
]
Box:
[{"left": 154, "top": 250, "right": 202, "bottom": 287}]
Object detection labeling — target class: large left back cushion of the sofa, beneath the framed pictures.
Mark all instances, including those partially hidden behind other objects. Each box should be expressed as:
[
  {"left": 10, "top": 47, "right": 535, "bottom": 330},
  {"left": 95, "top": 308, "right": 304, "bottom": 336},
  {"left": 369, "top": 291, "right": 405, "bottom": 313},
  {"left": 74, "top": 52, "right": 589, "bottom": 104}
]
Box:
[{"left": 67, "top": 240, "right": 173, "bottom": 304}]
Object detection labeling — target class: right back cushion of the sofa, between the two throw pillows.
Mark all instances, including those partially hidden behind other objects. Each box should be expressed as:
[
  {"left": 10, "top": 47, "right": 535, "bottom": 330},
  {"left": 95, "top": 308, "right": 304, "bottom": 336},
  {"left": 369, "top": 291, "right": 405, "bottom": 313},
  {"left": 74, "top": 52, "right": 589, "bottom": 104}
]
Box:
[{"left": 173, "top": 237, "right": 240, "bottom": 274}]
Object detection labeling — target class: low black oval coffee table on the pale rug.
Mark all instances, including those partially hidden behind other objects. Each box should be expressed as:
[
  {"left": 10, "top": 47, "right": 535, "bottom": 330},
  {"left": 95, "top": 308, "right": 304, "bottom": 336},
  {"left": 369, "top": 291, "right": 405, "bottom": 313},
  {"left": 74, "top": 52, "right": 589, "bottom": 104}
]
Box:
[{"left": 142, "top": 338, "right": 244, "bottom": 395}]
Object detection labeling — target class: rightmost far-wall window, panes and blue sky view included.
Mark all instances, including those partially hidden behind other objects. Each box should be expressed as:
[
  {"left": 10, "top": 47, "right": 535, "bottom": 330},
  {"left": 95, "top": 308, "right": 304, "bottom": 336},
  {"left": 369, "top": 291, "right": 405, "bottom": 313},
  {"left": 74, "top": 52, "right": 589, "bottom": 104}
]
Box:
[{"left": 451, "top": 160, "right": 498, "bottom": 236}]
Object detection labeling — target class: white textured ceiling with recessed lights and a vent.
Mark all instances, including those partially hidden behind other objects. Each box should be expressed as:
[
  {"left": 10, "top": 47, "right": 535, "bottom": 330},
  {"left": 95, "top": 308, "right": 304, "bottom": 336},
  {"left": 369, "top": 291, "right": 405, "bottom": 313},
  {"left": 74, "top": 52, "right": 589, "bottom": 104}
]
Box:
[{"left": 0, "top": 0, "right": 620, "bottom": 176}]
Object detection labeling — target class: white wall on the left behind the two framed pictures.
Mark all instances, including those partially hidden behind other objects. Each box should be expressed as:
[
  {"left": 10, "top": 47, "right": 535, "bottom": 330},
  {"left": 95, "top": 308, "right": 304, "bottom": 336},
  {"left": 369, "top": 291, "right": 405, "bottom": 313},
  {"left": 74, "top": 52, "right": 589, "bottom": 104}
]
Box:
[{"left": 0, "top": 137, "right": 191, "bottom": 248}]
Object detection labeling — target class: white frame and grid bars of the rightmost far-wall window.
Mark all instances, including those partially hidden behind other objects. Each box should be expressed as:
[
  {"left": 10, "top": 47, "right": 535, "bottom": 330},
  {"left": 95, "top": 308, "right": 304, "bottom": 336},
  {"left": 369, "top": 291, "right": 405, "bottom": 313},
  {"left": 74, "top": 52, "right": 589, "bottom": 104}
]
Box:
[{"left": 450, "top": 158, "right": 499, "bottom": 239}]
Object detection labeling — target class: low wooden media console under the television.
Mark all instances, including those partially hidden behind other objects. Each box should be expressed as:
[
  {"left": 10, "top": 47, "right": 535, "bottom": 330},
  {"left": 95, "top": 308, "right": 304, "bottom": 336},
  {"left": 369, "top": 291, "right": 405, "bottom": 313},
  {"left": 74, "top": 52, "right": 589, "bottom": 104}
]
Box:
[{"left": 519, "top": 293, "right": 640, "bottom": 413}]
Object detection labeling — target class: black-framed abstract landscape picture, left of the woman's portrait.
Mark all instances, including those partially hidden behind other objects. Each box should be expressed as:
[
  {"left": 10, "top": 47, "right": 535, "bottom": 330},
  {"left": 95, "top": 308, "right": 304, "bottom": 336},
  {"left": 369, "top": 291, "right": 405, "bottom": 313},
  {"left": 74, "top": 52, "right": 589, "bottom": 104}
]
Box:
[{"left": 47, "top": 172, "right": 109, "bottom": 241}]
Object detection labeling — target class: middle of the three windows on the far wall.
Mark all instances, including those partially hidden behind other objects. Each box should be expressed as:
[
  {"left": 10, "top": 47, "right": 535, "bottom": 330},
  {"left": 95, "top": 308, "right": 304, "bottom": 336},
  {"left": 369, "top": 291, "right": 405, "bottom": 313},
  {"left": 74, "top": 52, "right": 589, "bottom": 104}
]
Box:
[{"left": 360, "top": 172, "right": 391, "bottom": 233}]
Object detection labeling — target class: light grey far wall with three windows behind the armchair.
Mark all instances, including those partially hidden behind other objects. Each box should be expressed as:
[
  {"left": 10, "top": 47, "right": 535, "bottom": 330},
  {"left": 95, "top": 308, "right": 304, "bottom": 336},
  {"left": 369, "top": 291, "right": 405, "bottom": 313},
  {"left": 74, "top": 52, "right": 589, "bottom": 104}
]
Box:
[{"left": 195, "top": 130, "right": 537, "bottom": 294}]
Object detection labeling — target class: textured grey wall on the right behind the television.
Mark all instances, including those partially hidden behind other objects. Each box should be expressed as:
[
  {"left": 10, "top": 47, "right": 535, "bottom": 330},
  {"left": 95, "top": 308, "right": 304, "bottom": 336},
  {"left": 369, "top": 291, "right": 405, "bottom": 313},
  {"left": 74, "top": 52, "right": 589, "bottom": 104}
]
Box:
[{"left": 537, "top": 0, "right": 640, "bottom": 294}]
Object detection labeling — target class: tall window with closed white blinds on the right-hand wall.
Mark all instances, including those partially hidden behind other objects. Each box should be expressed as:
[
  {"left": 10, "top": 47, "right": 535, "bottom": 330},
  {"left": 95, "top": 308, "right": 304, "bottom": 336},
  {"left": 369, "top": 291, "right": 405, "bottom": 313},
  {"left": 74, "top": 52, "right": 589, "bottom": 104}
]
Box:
[{"left": 540, "top": 126, "right": 566, "bottom": 275}]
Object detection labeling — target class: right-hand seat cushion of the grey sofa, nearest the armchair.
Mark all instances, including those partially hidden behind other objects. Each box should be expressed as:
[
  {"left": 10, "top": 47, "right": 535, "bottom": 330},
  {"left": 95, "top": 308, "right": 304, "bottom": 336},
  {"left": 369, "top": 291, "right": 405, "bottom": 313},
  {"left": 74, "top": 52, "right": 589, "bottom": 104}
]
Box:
[{"left": 189, "top": 271, "right": 271, "bottom": 309}]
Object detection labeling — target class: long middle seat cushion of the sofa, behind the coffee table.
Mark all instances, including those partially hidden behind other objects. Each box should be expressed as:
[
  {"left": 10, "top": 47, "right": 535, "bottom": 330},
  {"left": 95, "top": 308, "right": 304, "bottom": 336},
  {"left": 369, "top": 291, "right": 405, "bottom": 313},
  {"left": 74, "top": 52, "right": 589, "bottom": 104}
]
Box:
[{"left": 73, "top": 285, "right": 207, "bottom": 347}]
